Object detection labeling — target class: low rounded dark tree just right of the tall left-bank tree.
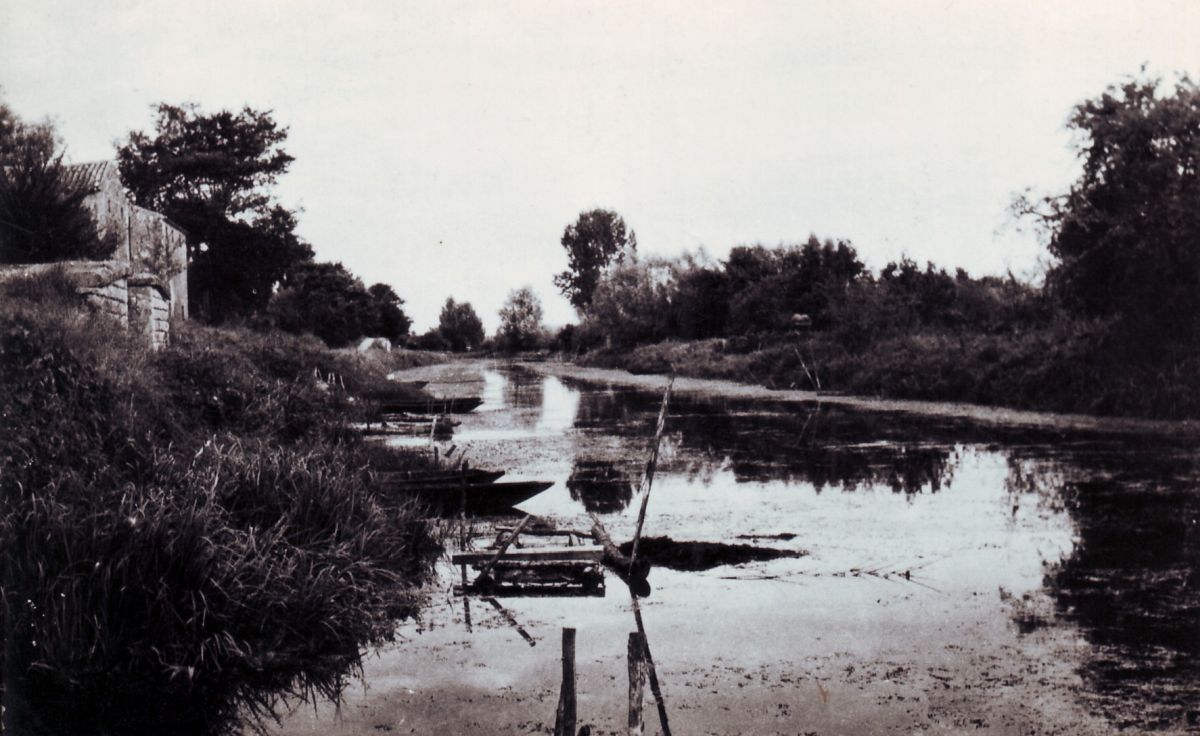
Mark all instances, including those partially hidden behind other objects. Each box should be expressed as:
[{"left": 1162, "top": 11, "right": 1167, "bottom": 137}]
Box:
[{"left": 268, "top": 262, "right": 379, "bottom": 347}]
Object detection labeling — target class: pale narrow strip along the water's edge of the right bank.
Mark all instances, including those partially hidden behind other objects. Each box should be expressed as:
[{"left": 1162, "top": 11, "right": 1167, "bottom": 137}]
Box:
[{"left": 521, "top": 361, "right": 1200, "bottom": 437}]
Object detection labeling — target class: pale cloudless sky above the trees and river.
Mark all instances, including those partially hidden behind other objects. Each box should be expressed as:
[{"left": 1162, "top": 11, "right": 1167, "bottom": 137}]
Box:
[{"left": 0, "top": 0, "right": 1200, "bottom": 330}]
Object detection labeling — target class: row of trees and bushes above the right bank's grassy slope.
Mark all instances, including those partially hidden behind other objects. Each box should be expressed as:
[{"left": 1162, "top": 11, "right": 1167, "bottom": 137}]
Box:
[{"left": 556, "top": 76, "right": 1200, "bottom": 360}]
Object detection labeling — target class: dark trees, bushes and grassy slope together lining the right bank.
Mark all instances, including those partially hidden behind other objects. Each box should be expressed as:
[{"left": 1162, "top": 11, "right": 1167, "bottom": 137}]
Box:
[{"left": 556, "top": 77, "right": 1200, "bottom": 418}]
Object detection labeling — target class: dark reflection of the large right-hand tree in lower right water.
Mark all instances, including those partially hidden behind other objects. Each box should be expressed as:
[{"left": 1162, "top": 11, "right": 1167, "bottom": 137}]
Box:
[{"left": 1045, "top": 454, "right": 1200, "bottom": 729}]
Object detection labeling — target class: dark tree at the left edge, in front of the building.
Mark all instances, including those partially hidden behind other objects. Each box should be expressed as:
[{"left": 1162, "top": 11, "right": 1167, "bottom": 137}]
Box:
[{"left": 0, "top": 104, "right": 116, "bottom": 263}]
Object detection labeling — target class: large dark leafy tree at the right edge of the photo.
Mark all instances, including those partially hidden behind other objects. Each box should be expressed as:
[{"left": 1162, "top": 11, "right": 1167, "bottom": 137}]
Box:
[{"left": 1018, "top": 76, "right": 1200, "bottom": 342}]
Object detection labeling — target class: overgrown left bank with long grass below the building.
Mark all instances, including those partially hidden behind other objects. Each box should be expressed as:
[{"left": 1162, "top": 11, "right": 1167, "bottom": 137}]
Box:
[{"left": 0, "top": 273, "right": 437, "bottom": 734}]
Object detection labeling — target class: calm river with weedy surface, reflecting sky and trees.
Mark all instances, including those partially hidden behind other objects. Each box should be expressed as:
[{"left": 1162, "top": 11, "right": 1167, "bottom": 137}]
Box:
[{"left": 277, "top": 364, "right": 1200, "bottom": 734}]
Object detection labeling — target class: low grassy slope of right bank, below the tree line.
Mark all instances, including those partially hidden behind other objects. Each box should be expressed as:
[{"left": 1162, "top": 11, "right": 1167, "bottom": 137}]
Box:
[{"left": 578, "top": 322, "right": 1200, "bottom": 419}]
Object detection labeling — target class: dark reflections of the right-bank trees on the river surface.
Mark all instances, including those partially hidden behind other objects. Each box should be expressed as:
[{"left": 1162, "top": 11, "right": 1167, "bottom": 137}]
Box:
[{"left": 568, "top": 372, "right": 1200, "bottom": 730}]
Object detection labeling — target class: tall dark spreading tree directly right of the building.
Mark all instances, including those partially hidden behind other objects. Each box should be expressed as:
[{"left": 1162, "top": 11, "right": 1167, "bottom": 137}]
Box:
[{"left": 118, "top": 104, "right": 312, "bottom": 322}]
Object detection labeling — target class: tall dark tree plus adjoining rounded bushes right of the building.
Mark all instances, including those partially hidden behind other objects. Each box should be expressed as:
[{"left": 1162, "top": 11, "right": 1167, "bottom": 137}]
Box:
[{"left": 118, "top": 104, "right": 412, "bottom": 347}]
